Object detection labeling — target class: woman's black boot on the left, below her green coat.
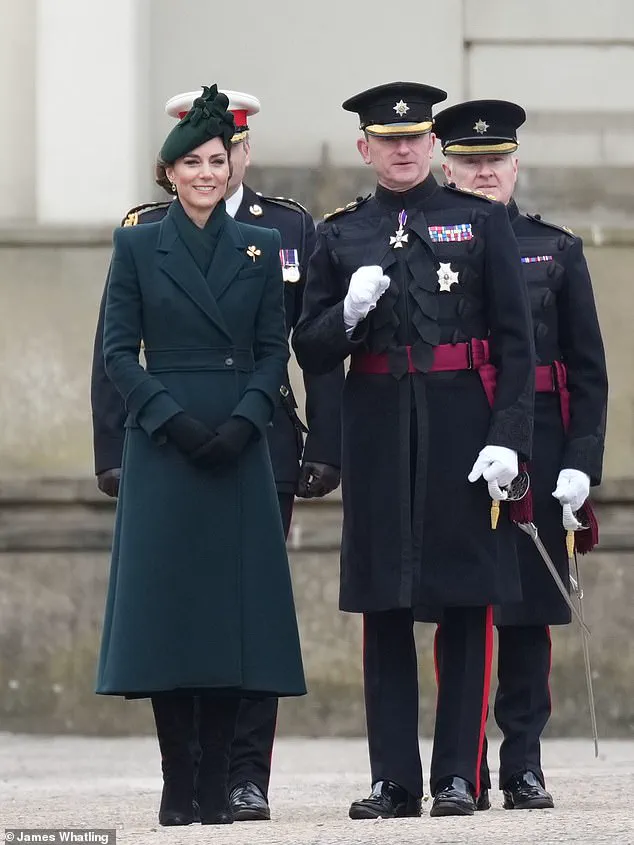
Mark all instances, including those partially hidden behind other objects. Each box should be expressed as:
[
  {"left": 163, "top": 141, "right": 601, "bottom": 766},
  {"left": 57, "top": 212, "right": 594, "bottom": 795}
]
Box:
[{"left": 152, "top": 694, "right": 194, "bottom": 826}]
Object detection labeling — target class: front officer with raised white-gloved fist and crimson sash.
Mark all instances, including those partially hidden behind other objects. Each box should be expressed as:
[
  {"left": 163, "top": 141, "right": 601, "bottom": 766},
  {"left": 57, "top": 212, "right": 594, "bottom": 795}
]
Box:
[{"left": 294, "top": 82, "right": 534, "bottom": 818}]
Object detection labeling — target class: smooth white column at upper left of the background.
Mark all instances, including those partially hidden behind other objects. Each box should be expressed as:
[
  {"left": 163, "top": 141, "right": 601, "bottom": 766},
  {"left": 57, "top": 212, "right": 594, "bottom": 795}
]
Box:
[{"left": 35, "top": 0, "right": 152, "bottom": 225}]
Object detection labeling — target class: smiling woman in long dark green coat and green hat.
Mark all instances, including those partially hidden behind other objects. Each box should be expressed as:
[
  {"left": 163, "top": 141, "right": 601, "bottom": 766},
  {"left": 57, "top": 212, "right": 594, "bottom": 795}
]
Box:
[{"left": 97, "top": 86, "right": 306, "bottom": 824}]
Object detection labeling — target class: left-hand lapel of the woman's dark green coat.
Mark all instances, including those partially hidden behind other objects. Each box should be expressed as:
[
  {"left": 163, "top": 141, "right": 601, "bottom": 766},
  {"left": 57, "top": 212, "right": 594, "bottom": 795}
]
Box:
[{"left": 157, "top": 214, "right": 233, "bottom": 341}]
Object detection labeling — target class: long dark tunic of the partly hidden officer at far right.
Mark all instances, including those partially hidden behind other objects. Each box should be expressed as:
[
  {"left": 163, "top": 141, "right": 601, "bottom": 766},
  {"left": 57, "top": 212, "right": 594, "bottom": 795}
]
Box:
[{"left": 495, "top": 201, "right": 608, "bottom": 625}]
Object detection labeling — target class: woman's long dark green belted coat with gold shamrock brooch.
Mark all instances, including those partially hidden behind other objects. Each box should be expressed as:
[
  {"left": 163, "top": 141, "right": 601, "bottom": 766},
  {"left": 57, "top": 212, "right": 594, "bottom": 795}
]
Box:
[{"left": 97, "top": 201, "right": 306, "bottom": 696}]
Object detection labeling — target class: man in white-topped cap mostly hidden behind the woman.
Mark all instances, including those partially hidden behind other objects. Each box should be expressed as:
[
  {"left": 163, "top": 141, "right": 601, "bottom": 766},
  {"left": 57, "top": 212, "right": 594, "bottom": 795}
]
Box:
[{"left": 91, "top": 85, "right": 343, "bottom": 820}]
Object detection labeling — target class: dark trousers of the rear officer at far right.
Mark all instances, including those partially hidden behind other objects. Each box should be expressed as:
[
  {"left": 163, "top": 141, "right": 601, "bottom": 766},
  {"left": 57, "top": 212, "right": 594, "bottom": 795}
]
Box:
[{"left": 481, "top": 625, "right": 551, "bottom": 789}]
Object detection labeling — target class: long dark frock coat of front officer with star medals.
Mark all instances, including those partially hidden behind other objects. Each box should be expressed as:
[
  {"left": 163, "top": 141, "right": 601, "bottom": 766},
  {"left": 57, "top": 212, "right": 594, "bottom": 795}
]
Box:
[{"left": 294, "top": 175, "right": 534, "bottom": 612}]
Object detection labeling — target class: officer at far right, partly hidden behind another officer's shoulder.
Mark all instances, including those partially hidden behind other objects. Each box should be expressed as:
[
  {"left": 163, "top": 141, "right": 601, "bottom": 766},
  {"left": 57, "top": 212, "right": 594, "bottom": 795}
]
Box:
[{"left": 435, "top": 100, "right": 608, "bottom": 809}]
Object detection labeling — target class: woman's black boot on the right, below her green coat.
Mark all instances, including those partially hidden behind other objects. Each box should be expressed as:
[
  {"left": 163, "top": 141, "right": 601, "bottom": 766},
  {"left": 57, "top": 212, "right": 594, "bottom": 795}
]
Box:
[{"left": 197, "top": 694, "right": 240, "bottom": 824}]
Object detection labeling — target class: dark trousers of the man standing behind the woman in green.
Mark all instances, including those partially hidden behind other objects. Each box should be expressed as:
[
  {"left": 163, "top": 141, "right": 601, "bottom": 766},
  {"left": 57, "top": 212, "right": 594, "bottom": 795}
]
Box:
[{"left": 190, "top": 491, "right": 295, "bottom": 796}]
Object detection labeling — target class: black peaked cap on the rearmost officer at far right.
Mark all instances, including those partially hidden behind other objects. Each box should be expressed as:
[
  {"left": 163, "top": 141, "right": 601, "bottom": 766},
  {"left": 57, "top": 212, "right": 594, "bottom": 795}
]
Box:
[{"left": 434, "top": 100, "right": 526, "bottom": 155}]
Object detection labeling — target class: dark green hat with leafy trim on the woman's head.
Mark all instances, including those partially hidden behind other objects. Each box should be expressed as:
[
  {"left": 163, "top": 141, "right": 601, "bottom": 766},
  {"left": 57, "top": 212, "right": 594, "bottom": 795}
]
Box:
[{"left": 159, "top": 85, "right": 235, "bottom": 164}]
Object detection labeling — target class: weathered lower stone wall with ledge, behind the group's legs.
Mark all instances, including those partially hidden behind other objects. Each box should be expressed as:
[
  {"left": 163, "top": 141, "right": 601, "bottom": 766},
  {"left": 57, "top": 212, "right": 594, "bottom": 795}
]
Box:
[{"left": 0, "top": 478, "right": 634, "bottom": 736}]
